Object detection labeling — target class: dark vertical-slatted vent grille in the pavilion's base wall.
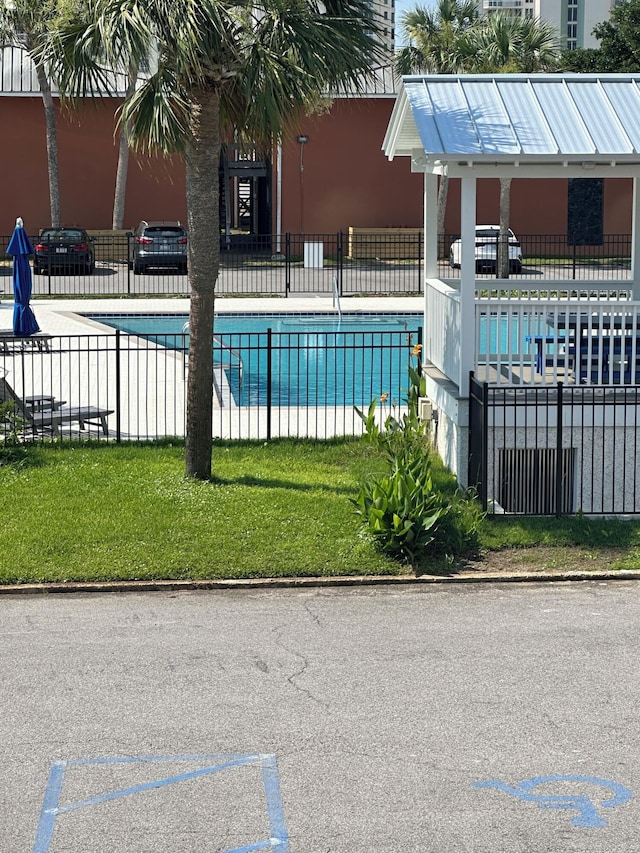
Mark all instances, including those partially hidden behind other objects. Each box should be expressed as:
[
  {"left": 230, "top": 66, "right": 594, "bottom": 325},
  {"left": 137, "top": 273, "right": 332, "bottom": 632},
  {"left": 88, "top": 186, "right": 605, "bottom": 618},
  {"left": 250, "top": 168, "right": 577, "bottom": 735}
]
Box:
[{"left": 498, "top": 447, "right": 576, "bottom": 515}]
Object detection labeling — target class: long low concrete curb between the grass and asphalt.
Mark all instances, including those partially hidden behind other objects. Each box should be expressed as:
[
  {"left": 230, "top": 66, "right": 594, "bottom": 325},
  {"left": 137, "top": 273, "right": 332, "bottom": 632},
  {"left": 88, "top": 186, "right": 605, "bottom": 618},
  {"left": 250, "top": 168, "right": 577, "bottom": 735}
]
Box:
[{"left": 0, "top": 570, "right": 640, "bottom": 595}]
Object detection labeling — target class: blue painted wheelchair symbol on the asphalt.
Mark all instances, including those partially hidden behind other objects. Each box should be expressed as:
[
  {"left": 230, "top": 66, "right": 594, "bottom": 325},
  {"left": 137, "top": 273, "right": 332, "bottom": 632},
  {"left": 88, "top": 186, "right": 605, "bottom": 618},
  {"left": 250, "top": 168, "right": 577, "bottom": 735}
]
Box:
[{"left": 474, "top": 776, "right": 633, "bottom": 828}]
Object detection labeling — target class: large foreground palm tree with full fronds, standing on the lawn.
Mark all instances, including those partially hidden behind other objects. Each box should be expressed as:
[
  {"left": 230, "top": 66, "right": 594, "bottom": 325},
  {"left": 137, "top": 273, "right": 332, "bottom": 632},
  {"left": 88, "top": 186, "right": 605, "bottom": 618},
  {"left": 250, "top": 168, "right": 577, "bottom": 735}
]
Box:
[{"left": 48, "top": 0, "right": 384, "bottom": 479}]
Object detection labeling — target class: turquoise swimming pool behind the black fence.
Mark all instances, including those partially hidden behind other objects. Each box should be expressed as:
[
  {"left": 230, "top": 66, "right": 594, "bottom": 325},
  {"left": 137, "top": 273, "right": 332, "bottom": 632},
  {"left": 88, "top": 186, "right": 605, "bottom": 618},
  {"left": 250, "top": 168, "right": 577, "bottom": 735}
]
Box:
[{"left": 85, "top": 313, "right": 423, "bottom": 406}]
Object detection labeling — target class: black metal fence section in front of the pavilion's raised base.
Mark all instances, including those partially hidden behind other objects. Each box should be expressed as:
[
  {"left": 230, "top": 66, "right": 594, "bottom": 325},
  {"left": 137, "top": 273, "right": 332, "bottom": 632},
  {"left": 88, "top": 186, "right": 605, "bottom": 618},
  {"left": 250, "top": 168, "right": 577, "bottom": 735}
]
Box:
[{"left": 469, "top": 377, "right": 640, "bottom": 515}]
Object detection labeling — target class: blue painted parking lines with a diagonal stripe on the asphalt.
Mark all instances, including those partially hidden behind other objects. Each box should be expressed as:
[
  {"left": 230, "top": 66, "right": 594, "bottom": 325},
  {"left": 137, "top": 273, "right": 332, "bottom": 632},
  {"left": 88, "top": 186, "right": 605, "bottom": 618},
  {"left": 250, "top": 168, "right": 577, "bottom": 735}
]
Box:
[{"left": 33, "top": 754, "right": 289, "bottom": 853}]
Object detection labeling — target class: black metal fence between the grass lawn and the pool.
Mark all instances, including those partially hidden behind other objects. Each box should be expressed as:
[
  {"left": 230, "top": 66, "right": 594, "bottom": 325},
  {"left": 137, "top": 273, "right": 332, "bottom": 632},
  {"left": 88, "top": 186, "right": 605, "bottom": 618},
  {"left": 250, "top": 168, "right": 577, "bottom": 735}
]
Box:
[{"left": 0, "top": 327, "right": 421, "bottom": 442}]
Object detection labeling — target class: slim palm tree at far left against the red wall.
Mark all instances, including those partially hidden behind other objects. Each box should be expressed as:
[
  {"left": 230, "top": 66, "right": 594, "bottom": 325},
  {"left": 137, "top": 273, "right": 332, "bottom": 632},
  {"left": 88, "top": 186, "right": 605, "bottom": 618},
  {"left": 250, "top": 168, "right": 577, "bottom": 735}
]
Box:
[{"left": 0, "top": 0, "right": 71, "bottom": 228}]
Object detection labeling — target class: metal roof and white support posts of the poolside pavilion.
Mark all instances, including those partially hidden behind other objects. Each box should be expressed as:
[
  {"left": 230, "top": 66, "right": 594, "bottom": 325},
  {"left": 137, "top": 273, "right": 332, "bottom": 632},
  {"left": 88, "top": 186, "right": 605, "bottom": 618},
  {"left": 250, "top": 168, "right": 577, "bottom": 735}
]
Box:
[{"left": 382, "top": 74, "right": 640, "bottom": 389}]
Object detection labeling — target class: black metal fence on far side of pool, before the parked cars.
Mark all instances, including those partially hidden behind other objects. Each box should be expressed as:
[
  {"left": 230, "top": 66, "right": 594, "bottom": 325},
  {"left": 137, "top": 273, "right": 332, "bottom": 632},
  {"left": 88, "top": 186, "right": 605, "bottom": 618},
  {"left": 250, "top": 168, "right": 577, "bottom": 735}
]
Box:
[{"left": 0, "top": 229, "right": 631, "bottom": 297}]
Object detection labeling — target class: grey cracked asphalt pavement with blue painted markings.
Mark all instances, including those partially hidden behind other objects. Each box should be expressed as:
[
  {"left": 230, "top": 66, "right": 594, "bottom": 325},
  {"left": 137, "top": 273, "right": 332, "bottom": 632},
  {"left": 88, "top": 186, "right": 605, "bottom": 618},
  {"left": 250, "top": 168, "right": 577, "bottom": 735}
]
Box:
[{"left": 0, "top": 581, "right": 640, "bottom": 853}]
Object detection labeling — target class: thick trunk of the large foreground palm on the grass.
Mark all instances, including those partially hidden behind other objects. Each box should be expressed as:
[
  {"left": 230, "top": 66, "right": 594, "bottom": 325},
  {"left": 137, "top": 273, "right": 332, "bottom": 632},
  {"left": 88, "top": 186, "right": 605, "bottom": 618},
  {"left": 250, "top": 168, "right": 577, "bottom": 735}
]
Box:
[{"left": 185, "top": 90, "right": 220, "bottom": 480}]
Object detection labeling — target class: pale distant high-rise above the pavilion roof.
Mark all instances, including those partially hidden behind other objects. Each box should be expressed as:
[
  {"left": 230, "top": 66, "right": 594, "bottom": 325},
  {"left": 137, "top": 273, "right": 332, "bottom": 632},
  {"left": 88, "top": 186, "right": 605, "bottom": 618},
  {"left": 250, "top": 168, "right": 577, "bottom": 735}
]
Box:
[{"left": 478, "top": 0, "right": 620, "bottom": 50}]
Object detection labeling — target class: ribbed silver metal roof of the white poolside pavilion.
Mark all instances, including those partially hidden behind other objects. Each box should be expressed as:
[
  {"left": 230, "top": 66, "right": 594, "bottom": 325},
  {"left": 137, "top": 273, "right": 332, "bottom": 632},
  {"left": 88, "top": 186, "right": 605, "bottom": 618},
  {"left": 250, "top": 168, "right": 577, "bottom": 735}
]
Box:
[{"left": 385, "top": 74, "right": 640, "bottom": 164}]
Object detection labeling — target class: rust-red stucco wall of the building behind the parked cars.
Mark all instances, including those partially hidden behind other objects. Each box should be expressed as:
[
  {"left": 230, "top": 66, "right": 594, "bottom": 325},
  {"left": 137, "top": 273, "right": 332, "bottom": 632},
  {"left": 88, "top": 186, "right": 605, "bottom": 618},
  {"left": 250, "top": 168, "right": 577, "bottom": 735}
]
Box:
[{"left": 0, "top": 97, "right": 631, "bottom": 234}]
